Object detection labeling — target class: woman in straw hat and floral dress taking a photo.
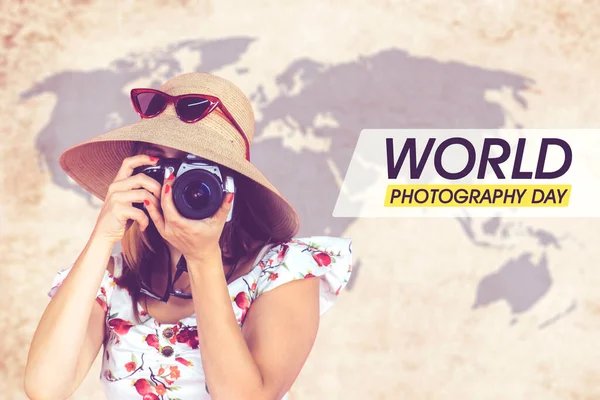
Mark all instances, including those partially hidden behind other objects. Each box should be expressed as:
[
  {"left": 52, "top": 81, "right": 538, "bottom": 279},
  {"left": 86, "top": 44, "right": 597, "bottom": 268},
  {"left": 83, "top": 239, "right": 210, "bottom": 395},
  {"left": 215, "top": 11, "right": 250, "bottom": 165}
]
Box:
[{"left": 25, "top": 73, "right": 351, "bottom": 400}]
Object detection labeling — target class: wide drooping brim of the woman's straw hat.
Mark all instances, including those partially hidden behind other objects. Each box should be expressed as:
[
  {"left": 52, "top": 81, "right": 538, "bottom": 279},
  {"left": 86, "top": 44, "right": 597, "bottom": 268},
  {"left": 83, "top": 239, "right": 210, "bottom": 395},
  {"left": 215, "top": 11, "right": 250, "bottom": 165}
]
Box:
[{"left": 59, "top": 113, "right": 299, "bottom": 240}]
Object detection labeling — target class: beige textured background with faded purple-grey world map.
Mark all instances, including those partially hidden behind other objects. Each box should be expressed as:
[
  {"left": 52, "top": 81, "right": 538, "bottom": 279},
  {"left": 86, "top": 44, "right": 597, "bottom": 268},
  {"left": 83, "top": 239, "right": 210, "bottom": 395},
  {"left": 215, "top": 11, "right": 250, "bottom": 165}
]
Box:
[{"left": 0, "top": 0, "right": 600, "bottom": 400}]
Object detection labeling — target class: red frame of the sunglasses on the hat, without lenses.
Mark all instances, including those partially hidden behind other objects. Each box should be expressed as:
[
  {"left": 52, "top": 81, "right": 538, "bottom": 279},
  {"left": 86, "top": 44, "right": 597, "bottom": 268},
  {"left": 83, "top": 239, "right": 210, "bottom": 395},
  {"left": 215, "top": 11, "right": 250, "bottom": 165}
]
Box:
[{"left": 131, "top": 88, "right": 250, "bottom": 161}]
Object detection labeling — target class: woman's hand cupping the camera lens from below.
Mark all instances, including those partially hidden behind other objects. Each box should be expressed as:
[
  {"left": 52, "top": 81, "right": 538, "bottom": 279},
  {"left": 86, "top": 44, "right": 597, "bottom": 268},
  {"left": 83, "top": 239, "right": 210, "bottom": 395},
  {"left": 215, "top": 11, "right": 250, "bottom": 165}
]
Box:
[{"left": 146, "top": 169, "right": 233, "bottom": 262}]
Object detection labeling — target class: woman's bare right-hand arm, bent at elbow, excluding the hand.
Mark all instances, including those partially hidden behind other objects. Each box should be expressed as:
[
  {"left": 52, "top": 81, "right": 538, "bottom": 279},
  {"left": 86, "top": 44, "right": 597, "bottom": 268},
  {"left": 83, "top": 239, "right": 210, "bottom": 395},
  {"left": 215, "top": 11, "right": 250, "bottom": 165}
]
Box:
[{"left": 188, "top": 250, "right": 319, "bottom": 400}]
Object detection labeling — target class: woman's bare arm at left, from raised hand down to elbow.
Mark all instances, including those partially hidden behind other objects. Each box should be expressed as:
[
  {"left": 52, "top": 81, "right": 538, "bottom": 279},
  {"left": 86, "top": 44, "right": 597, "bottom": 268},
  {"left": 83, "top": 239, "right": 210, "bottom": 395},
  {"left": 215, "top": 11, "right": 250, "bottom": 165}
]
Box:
[{"left": 24, "top": 154, "right": 160, "bottom": 400}]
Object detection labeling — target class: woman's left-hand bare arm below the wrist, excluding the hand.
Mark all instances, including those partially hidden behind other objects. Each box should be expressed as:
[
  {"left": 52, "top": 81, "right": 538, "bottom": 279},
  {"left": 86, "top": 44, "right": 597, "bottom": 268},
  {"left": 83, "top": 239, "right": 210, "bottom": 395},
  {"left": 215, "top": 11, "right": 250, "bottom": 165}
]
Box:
[{"left": 24, "top": 235, "right": 114, "bottom": 400}]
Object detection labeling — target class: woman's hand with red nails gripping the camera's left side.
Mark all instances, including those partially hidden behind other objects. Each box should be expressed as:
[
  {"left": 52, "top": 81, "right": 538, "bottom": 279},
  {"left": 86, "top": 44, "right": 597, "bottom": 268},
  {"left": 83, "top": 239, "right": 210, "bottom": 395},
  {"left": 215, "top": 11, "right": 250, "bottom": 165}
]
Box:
[{"left": 94, "top": 154, "right": 162, "bottom": 243}]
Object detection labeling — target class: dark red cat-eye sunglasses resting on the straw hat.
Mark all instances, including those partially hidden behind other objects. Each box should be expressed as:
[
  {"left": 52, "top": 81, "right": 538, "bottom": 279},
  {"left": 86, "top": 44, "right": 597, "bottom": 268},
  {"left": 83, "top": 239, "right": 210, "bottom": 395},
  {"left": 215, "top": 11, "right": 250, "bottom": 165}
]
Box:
[{"left": 131, "top": 88, "right": 250, "bottom": 161}]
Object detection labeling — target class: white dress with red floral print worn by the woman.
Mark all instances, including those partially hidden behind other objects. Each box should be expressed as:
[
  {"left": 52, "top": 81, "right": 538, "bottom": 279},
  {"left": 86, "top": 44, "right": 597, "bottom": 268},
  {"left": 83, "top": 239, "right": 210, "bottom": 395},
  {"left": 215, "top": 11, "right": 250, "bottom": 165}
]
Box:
[{"left": 48, "top": 236, "right": 352, "bottom": 400}]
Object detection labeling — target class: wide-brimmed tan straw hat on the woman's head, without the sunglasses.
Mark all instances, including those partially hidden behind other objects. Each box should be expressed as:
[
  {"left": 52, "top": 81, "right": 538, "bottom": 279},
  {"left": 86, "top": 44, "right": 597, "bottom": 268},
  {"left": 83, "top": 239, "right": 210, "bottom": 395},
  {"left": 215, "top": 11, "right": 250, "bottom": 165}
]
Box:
[{"left": 59, "top": 72, "right": 299, "bottom": 240}]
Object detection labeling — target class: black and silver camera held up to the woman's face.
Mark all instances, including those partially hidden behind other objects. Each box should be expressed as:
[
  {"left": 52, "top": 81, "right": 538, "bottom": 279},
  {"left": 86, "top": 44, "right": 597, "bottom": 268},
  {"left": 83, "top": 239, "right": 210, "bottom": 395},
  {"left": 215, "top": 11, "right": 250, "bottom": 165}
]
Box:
[{"left": 133, "top": 154, "right": 235, "bottom": 222}]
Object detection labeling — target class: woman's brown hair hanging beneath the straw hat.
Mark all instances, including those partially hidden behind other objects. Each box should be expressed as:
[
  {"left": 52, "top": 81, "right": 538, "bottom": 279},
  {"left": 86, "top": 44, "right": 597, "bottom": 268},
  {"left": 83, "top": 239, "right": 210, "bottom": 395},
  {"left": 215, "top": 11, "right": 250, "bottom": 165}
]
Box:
[{"left": 116, "top": 142, "right": 280, "bottom": 323}]
